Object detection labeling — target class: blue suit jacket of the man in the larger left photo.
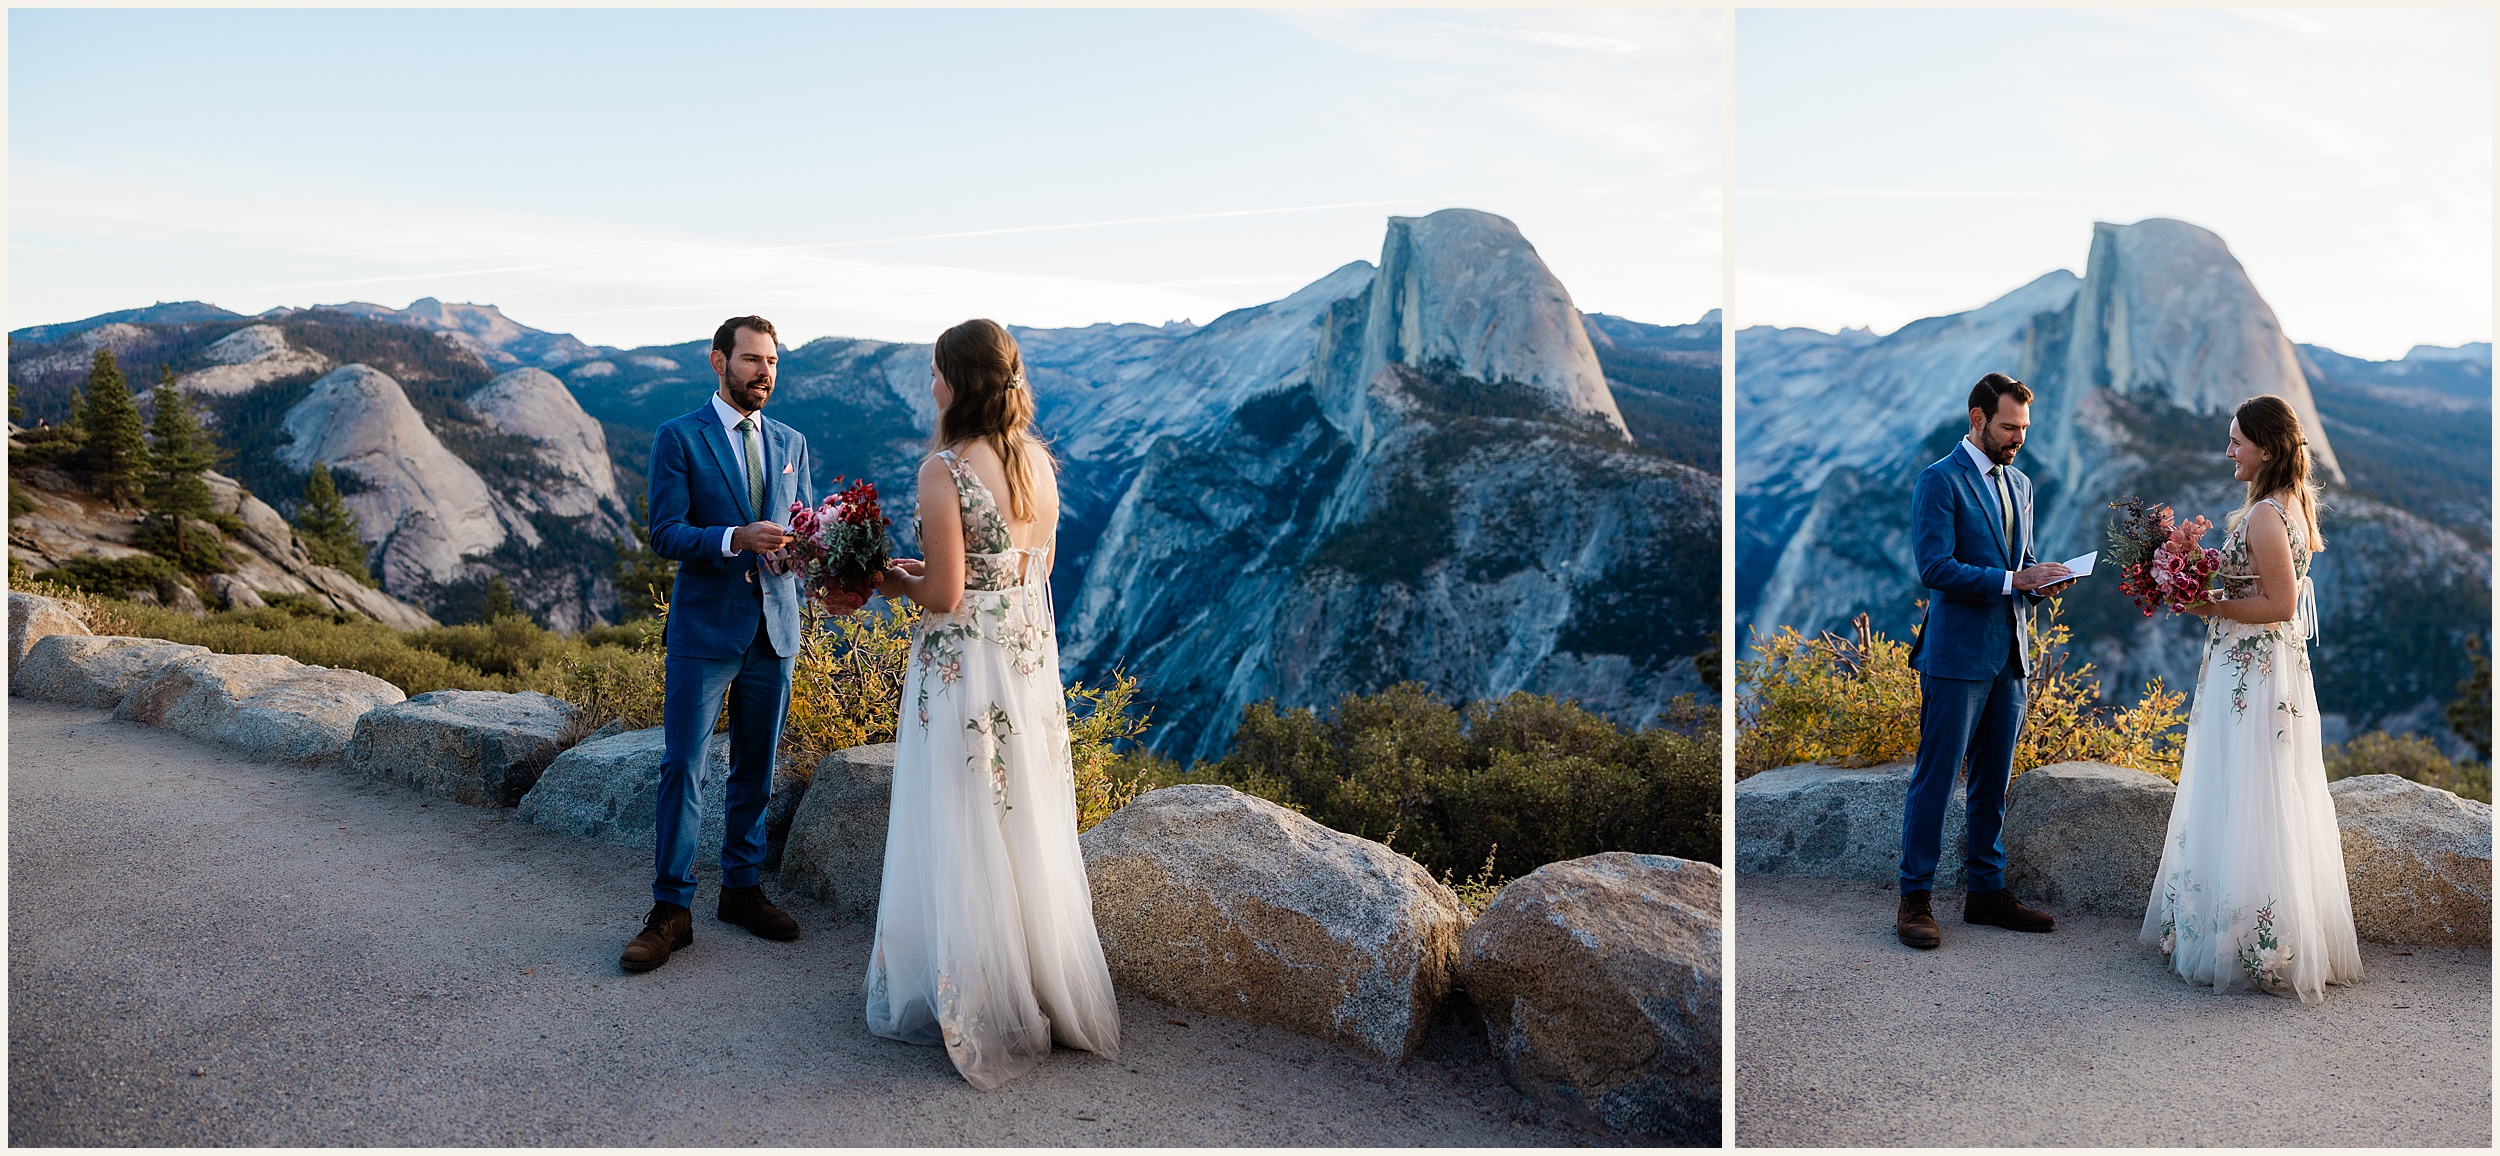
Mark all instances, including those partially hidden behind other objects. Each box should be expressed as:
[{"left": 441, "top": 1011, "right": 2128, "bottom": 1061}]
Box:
[{"left": 650, "top": 398, "right": 815, "bottom": 658}]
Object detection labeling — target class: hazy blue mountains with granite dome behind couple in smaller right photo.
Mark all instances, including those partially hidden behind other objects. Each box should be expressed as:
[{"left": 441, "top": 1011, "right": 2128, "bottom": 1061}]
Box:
[{"left": 1735, "top": 220, "right": 2490, "bottom": 750}]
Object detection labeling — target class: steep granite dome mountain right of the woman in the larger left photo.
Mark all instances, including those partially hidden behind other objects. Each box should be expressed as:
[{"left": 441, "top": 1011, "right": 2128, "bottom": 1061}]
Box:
[{"left": 1060, "top": 210, "right": 1718, "bottom": 758}]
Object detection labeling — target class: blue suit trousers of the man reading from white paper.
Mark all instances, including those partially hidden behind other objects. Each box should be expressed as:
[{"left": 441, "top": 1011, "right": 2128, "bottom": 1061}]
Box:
[{"left": 1900, "top": 661, "right": 2030, "bottom": 896}]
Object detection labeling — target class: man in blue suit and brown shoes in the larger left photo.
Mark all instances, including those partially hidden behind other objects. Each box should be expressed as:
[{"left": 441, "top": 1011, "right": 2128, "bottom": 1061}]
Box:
[{"left": 618, "top": 318, "right": 815, "bottom": 971}]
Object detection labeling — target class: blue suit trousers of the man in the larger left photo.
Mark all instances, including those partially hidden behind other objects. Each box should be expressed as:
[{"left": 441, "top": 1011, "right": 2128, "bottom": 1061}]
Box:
[{"left": 650, "top": 623, "right": 798, "bottom": 908}]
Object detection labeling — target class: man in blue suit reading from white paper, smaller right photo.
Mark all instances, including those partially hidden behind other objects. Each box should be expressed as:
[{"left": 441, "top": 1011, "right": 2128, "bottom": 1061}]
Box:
[{"left": 1895, "top": 373, "right": 2073, "bottom": 948}]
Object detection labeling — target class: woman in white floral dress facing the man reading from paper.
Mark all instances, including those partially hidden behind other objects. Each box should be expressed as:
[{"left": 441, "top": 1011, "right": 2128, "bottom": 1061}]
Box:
[{"left": 2140, "top": 395, "right": 2360, "bottom": 1003}]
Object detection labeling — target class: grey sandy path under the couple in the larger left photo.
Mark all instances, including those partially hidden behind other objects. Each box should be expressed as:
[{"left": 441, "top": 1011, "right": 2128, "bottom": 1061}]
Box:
[{"left": 8, "top": 698, "right": 1608, "bottom": 1146}]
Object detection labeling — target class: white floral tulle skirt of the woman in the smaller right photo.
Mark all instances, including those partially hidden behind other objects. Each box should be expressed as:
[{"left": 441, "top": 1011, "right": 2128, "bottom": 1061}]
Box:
[{"left": 2140, "top": 621, "right": 2360, "bottom": 1003}]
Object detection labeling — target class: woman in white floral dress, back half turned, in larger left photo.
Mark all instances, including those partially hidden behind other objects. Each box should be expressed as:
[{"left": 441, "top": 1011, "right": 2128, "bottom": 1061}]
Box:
[{"left": 865, "top": 320, "right": 1120, "bottom": 1091}]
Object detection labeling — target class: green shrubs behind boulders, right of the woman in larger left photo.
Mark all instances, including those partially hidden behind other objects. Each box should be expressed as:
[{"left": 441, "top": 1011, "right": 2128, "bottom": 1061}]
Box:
[{"left": 1150, "top": 683, "right": 1720, "bottom": 886}]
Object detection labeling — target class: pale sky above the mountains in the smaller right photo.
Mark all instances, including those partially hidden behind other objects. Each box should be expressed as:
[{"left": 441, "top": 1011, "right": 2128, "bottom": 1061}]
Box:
[{"left": 1733, "top": 8, "right": 2493, "bottom": 358}]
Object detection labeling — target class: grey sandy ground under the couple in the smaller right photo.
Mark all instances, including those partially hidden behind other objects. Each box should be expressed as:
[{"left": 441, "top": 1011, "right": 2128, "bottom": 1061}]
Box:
[{"left": 1733, "top": 876, "right": 2493, "bottom": 1148}]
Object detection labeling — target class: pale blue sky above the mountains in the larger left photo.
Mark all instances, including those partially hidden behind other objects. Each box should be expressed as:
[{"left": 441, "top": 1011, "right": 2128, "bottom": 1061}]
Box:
[{"left": 8, "top": 10, "right": 1720, "bottom": 345}]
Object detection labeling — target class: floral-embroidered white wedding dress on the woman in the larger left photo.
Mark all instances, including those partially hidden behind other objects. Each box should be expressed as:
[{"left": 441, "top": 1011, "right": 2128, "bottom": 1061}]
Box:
[{"left": 868, "top": 453, "right": 1120, "bottom": 1091}]
